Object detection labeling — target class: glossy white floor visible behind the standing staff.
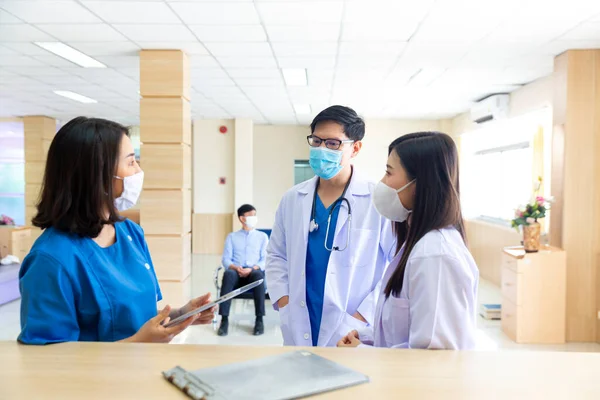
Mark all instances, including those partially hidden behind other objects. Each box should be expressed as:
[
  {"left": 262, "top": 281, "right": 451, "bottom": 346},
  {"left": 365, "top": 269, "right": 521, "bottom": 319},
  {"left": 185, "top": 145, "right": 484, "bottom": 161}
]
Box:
[{"left": 0, "top": 256, "right": 600, "bottom": 352}]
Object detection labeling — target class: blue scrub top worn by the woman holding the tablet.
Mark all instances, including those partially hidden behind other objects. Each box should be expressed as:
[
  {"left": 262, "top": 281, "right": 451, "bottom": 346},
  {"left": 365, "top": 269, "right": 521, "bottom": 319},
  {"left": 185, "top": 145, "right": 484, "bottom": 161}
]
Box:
[{"left": 18, "top": 220, "right": 162, "bottom": 344}]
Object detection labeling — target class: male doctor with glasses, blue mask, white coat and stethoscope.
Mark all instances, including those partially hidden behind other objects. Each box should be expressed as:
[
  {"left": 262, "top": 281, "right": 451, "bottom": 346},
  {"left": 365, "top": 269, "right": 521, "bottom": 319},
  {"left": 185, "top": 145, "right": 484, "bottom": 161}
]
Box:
[{"left": 265, "top": 106, "right": 396, "bottom": 346}]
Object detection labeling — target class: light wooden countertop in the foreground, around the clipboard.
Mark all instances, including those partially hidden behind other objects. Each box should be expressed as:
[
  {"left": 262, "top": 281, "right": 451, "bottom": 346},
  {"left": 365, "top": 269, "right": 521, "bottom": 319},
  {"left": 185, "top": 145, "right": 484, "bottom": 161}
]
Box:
[{"left": 0, "top": 342, "right": 600, "bottom": 400}]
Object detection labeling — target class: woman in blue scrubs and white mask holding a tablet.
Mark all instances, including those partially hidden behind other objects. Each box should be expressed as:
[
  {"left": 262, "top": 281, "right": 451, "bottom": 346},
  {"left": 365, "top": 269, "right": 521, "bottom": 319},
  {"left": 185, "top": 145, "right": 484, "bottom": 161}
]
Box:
[{"left": 18, "top": 117, "right": 214, "bottom": 344}]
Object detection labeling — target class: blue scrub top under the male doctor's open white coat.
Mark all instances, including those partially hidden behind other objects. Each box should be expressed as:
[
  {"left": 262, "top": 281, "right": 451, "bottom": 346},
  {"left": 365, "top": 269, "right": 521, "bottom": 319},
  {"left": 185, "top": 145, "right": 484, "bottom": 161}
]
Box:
[{"left": 306, "top": 196, "right": 340, "bottom": 346}]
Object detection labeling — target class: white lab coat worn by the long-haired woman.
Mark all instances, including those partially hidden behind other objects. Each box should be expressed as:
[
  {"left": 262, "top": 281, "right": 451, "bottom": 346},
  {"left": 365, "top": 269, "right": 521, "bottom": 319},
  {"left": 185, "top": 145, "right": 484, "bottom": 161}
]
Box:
[{"left": 358, "top": 228, "right": 479, "bottom": 350}]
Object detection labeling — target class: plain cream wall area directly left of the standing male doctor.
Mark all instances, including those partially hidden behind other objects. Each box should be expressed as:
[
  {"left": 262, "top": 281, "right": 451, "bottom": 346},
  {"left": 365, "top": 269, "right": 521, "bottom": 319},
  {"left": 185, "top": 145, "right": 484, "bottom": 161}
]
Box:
[{"left": 254, "top": 125, "right": 310, "bottom": 229}]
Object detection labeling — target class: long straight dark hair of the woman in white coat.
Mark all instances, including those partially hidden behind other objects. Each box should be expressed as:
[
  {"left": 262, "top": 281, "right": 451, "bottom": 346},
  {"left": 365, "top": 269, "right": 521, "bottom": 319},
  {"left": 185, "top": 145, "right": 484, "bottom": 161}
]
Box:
[{"left": 385, "top": 132, "right": 466, "bottom": 297}]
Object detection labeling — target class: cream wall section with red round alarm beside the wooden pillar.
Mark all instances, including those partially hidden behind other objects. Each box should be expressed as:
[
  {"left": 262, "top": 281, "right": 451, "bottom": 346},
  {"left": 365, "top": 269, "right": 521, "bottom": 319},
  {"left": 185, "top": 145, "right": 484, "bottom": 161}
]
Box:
[{"left": 192, "top": 119, "right": 235, "bottom": 214}]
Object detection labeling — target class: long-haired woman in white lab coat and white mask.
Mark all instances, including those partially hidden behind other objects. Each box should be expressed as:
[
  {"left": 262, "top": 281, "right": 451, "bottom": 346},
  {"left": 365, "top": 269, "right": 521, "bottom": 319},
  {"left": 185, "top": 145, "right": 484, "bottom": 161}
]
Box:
[{"left": 338, "top": 132, "right": 479, "bottom": 350}]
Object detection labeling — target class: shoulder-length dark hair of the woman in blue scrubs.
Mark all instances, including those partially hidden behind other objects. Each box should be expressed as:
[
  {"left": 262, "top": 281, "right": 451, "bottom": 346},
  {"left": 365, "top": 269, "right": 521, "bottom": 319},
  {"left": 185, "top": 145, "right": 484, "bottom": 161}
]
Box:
[{"left": 32, "top": 117, "right": 129, "bottom": 238}]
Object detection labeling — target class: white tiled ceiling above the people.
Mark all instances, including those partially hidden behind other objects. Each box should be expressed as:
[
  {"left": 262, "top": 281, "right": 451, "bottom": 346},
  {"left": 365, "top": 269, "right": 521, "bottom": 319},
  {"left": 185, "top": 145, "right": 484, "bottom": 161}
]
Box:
[{"left": 0, "top": 0, "right": 600, "bottom": 124}]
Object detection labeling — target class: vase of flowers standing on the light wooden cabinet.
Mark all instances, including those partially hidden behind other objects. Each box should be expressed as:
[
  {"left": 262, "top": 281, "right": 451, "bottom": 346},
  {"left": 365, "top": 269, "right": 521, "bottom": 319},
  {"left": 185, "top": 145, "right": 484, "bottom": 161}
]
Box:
[{"left": 511, "top": 177, "right": 552, "bottom": 253}]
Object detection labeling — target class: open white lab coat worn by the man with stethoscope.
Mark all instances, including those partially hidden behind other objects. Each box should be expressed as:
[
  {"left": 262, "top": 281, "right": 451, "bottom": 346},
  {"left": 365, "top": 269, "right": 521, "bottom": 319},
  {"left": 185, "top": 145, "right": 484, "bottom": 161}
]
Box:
[{"left": 265, "top": 168, "right": 396, "bottom": 346}]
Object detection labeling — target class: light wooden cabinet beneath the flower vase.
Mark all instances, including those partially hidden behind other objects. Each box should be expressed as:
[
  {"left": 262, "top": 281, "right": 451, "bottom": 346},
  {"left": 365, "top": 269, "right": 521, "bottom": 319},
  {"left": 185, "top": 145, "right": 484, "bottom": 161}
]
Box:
[{"left": 502, "top": 246, "right": 567, "bottom": 344}]
